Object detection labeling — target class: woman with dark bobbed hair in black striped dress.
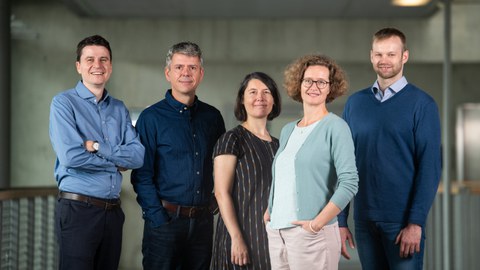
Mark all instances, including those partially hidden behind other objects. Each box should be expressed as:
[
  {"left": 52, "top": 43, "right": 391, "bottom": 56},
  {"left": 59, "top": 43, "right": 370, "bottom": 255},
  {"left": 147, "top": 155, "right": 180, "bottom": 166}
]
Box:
[{"left": 211, "top": 72, "right": 281, "bottom": 270}]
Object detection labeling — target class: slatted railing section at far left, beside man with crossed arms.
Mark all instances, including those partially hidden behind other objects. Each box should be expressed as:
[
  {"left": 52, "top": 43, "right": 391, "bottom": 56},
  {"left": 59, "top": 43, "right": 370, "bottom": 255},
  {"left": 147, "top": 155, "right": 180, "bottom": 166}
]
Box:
[{"left": 0, "top": 187, "right": 58, "bottom": 270}]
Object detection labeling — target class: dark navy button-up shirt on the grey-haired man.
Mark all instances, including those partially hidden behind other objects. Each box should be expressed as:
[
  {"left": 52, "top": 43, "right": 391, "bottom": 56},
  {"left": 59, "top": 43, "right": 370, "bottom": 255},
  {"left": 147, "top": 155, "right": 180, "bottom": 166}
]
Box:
[{"left": 132, "top": 90, "right": 225, "bottom": 226}]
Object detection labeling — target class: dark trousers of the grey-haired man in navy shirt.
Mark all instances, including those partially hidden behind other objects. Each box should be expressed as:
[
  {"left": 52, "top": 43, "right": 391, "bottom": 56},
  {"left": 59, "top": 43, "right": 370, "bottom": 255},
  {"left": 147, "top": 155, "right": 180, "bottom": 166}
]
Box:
[{"left": 142, "top": 214, "right": 213, "bottom": 270}]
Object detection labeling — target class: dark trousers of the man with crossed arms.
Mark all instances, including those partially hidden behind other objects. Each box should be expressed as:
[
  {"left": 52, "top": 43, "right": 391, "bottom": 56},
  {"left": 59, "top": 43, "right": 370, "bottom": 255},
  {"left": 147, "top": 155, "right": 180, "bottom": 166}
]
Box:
[{"left": 55, "top": 199, "right": 125, "bottom": 270}]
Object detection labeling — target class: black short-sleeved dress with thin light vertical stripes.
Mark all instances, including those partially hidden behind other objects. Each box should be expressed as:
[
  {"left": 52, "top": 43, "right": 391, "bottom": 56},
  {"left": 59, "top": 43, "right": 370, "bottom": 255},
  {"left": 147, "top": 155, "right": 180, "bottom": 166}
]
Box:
[{"left": 210, "top": 125, "right": 278, "bottom": 270}]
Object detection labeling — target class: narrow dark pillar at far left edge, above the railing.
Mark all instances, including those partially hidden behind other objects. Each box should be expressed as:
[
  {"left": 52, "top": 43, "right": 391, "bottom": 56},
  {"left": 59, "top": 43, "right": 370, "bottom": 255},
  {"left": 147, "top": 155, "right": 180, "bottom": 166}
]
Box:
[{"left": 0, "top": 0, "right": 11, "bottom": 189}]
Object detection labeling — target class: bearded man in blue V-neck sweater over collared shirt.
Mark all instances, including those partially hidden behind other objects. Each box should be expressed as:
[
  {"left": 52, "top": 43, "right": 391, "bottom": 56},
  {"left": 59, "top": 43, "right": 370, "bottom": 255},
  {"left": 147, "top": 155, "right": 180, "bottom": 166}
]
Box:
[{"left": 338, "top": 28, "right": 441, "bottom": 270}]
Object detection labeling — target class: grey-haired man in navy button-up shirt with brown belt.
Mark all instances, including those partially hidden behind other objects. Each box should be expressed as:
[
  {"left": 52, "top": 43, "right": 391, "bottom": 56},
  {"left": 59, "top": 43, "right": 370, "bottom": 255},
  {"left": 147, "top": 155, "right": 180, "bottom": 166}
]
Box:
[{"left": 131, "top": 42, "right": 225, "bottom": 270}]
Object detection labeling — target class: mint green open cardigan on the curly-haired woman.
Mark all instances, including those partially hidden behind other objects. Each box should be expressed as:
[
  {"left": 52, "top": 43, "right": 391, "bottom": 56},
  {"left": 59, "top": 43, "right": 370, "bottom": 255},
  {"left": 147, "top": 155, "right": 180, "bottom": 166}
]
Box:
[{"left": 268, "top": 113, "right": 358, "bottom": 224}]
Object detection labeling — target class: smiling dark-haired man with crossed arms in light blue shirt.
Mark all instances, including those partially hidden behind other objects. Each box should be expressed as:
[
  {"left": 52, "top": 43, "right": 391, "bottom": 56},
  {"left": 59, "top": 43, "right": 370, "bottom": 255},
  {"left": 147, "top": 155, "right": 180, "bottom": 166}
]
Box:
[{"left": 50, "top": 35, "right": 145, "bottom": 270}]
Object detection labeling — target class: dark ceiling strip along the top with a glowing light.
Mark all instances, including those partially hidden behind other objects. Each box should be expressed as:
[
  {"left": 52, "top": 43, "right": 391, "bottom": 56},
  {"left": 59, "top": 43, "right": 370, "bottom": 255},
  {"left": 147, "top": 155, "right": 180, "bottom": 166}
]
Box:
[{"left": 62, "top": 0, "right": 441, "bottom": 19}]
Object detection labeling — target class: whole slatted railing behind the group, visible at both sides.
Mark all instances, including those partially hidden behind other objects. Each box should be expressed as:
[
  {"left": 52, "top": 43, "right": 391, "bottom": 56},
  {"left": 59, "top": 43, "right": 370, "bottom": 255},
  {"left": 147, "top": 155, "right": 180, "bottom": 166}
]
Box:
[{"left": 0, "top": 181, "right": 480, "bottom": 270}]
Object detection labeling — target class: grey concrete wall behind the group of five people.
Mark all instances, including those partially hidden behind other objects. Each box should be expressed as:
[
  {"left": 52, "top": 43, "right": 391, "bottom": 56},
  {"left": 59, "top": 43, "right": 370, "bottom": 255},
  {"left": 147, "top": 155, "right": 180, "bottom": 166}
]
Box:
[{"left": 11, "top": 1, "right": 480, "bottom": 269}]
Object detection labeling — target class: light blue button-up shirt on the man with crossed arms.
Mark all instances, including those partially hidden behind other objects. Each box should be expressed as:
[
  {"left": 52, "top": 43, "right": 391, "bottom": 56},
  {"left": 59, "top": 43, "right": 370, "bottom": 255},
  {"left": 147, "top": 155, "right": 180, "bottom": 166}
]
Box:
[{"left": 49, "top": 81, "right": 145, "bottom": 199}]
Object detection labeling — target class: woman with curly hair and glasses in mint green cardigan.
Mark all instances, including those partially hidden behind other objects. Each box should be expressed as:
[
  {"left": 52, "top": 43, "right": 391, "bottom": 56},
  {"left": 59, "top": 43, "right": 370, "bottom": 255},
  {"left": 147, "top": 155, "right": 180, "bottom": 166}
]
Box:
[{"left": 264, "top": 55, "right": 358, "bottom": 270}]
